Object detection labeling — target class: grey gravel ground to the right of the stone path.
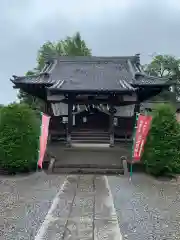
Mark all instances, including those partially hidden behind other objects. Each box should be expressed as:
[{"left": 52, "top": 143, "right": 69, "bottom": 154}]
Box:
[{"left": 108, "top": 174, "right": 180, "bottom": 240}]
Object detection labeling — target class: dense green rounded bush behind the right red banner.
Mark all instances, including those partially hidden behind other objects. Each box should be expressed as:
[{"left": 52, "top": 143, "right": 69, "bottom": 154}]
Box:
[{"left": 142, "top": 104, "right": 180, "bottom": 176}]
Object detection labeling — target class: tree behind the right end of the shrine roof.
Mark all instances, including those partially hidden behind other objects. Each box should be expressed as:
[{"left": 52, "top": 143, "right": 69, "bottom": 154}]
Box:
[{"left": 144, "top": 55, "right": 180, "bottom": 97}]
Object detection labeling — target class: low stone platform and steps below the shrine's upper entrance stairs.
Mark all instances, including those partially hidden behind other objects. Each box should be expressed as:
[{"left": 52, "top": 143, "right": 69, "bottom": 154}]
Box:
[{"left": 43, "top": 142, "right": 132, "bottom": 175}]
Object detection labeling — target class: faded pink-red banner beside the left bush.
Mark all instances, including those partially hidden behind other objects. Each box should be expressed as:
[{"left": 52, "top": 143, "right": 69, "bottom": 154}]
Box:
[{"left": 38, "top": 114, "right": 50, "bottom": 168}]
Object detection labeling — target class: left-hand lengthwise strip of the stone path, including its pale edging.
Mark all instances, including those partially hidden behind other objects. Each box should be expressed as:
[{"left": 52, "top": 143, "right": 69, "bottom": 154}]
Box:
[{"left": 35, "top": 175, "right": 79, "bottom": 240}]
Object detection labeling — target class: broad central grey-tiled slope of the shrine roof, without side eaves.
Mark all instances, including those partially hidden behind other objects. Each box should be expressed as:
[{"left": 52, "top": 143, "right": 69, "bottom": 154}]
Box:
[{"left": 47, "top": 57, "right": 138, "bottom": 91}]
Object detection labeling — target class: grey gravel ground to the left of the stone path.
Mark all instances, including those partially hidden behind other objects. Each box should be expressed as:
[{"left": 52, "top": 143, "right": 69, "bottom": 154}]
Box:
[{"left": 0, "top": 172, "right": 65, "bottom": 240}]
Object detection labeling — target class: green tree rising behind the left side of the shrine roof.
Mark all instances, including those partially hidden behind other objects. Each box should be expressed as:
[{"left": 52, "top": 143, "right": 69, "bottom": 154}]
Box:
[{"left": 18, "top": 32, "right": 91, "bottom": 107}]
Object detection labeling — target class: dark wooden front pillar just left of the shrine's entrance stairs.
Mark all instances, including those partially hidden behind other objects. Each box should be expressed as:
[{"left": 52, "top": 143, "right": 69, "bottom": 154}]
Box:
[{"left": 67, "top": 94, "right": 73, "bottom": 147}]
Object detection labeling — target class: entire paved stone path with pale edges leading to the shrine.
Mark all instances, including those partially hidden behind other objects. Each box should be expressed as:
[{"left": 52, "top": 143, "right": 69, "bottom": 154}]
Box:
[{"left": 35, "top": 175, "right": 122, "bottom": 240}]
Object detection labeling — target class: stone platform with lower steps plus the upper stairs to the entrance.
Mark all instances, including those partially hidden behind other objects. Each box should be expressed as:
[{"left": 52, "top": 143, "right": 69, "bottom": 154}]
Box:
[{"left": 43, "top": 129, "right": 132, "bottom": 175}]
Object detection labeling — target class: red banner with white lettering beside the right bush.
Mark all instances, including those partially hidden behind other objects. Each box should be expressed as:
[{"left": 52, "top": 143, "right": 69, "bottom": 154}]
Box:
[{"left": 133, "top": 115, "right": 152, "bottom": 161}]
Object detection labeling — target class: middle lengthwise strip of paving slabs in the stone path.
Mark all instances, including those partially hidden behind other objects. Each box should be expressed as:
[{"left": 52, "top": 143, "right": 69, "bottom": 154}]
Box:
[{"left": 64, "top": 176, "right": 95, "bottom": 240}]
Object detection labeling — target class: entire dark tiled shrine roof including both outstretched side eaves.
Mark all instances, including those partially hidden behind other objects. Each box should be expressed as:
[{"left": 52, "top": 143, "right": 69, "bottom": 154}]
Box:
[{"left": 12, "top": 55, "right": 172, "bottom": 91}]
